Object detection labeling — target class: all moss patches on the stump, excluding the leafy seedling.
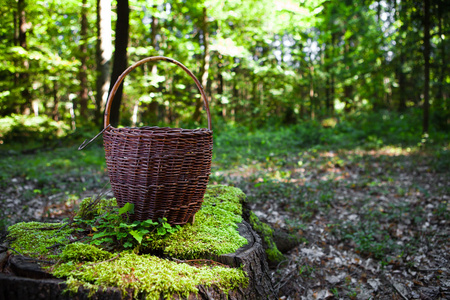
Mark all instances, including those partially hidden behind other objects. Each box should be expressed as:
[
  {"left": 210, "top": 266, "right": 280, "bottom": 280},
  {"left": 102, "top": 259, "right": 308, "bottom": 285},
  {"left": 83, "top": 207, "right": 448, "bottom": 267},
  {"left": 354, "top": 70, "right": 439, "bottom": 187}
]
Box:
[{"left": 9, "top": 186, "right": 248, "bottom": 299}]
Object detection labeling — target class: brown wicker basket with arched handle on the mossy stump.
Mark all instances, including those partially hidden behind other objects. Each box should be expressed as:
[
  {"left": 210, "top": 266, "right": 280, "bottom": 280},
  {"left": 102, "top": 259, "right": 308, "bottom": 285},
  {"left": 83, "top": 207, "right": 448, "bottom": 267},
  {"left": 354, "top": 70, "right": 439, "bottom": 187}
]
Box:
[{"left": 103, "top": 56, "right": 213, "bottom": 225}]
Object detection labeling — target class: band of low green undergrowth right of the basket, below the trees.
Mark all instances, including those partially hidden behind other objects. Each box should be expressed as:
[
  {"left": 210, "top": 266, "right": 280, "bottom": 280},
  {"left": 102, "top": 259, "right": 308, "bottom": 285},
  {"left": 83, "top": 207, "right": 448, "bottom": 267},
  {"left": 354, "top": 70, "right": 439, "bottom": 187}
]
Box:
[{"left": 214, "top": 111, "right": 450, "bottom": 168}]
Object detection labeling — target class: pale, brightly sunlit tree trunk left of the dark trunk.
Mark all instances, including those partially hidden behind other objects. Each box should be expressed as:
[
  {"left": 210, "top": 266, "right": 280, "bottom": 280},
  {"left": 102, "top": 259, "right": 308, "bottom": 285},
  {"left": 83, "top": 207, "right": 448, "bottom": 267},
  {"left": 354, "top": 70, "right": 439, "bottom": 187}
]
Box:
[{"left": 95, "top": 0, "right": 112, "bottom": 126}]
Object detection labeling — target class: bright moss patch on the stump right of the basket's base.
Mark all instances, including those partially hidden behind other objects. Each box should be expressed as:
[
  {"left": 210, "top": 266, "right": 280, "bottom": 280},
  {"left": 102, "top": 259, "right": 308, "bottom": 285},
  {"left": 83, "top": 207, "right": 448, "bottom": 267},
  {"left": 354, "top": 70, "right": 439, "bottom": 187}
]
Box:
[{"left": 147, "top": 185, "right": 247, "bottom": 259}]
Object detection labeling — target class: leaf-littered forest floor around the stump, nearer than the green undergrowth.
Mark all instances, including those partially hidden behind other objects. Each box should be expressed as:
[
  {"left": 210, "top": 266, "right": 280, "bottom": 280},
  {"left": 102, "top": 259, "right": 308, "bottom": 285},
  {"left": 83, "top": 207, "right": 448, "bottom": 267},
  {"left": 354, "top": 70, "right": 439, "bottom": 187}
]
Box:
[{"left": 0, "top": 147, "right": 450, "bottom": 299}]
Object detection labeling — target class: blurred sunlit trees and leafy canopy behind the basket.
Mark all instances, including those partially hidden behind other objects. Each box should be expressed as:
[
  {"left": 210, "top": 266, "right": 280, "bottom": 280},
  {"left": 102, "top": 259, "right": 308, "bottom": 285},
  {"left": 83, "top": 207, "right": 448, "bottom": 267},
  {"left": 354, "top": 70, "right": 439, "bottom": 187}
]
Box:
[{"left": 0, "top": 0, "right": 450, "bottom": 140}]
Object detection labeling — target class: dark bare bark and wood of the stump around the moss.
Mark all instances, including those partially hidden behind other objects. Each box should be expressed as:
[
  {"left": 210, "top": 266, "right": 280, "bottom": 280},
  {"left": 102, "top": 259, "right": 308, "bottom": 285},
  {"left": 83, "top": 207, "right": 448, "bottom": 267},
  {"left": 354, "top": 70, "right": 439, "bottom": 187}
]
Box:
[{"left": 0, "top": 221, "right": 275, "bottom": 300}]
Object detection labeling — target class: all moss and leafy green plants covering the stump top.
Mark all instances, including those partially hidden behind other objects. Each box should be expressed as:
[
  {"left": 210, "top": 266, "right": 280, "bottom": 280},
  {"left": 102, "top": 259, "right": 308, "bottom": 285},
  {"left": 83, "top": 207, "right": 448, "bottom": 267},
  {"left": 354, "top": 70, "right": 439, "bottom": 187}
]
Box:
[{"left": 8, "top": 186, "right": 248, "bottom": 299}]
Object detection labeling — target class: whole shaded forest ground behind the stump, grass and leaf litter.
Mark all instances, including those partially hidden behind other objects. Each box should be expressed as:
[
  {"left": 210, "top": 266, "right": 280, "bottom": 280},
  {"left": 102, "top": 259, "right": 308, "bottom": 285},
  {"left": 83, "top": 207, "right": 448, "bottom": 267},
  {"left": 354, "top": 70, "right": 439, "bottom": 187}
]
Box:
[{"left": 0, "top": 111, "right": 450, "bottom": 299}]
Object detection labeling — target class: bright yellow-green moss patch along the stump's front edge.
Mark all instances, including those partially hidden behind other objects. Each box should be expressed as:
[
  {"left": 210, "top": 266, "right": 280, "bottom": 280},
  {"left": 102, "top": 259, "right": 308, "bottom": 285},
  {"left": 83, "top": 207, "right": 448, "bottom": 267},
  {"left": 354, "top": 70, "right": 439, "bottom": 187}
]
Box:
[{"left": 52, "top": 251, "right": 248, "bottom": 299}]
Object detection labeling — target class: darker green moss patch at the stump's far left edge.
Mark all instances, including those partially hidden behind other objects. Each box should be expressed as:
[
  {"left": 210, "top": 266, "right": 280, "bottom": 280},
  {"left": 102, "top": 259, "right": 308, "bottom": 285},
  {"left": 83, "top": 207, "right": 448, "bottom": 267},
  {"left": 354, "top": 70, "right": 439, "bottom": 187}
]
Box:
[{"left": 8, "top": 222, "right": 73, "bottom": 258}]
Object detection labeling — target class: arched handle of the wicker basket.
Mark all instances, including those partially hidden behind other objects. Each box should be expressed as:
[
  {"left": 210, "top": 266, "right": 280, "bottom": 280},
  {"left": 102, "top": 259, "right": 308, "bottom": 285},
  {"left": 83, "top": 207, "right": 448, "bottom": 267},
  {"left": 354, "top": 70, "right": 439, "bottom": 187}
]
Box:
[{"left": 104, "top": 56, "right": 211, "bottom": 130}]
